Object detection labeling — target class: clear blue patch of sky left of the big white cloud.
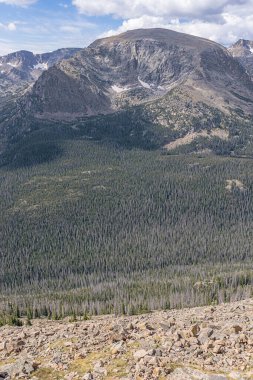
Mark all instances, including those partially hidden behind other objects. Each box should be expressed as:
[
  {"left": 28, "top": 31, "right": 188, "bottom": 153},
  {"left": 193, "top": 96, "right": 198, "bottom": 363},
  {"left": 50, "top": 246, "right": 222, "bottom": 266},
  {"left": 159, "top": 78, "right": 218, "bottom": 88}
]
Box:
[{"left": 0, "top": 0, "right": 120, "bottom": 55}]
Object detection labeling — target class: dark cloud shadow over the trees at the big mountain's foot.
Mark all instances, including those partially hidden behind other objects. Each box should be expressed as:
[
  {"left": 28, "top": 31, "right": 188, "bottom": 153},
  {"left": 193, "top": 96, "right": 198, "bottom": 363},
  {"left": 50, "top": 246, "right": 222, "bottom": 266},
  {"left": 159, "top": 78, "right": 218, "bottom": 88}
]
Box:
[{"left": 0, "top": 112, "right": 168, "bottom": 169}]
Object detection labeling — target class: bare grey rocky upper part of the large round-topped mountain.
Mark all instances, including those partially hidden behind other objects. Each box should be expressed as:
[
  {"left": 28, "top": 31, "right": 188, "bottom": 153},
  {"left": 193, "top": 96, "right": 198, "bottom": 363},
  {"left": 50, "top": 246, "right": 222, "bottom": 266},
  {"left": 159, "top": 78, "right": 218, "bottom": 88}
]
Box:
[{"left": 29, "top": 29, "right": 253, "bottom": 119}]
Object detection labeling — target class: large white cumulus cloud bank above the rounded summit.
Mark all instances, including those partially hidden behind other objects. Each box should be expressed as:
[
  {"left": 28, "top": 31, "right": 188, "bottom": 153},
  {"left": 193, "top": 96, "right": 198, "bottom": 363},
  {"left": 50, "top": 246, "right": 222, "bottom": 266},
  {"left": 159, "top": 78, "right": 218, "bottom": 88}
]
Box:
[{"left": 72, "top": 0, "right": 253, "bottom": 45}]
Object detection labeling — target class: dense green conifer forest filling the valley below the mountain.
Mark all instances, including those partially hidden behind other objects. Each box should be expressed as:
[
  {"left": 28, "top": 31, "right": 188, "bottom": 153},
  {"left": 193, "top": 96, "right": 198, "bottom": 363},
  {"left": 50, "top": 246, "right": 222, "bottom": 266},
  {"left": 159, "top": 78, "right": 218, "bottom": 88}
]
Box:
[{"left": 0, "top": 127, "right": 253, "bottom": 320}]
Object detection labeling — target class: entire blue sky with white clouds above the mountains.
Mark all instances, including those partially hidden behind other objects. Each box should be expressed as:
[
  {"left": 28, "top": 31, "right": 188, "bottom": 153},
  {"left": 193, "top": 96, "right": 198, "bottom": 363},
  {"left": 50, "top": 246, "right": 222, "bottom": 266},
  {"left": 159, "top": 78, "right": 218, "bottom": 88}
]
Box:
[{"left": 0, "top": 0, "right": 253, "bottom": 55}]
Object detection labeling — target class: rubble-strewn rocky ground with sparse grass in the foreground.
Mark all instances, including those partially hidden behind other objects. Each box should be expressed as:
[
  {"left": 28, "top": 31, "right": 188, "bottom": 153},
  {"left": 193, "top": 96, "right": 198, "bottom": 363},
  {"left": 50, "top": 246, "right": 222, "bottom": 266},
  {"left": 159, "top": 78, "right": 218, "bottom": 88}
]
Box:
[{"left": 0, "top": 299, "right": 253, "bottom": 380}]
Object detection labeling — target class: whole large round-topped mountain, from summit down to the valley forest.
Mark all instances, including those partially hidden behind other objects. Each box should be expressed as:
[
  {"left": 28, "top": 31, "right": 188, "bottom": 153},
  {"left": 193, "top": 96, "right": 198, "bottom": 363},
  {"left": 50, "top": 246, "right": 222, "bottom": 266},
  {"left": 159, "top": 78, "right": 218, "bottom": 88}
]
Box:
[{"left": 0, "top": 29, "right": 253, "bottom": 159}]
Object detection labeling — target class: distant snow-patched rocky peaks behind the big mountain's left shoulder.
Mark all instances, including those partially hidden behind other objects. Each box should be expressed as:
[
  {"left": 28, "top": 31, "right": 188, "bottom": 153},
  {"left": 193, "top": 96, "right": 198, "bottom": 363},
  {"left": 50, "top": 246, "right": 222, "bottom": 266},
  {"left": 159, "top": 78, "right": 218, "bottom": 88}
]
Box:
[{"left": 0, "top": 48, "right": 80, "bottom": 107}]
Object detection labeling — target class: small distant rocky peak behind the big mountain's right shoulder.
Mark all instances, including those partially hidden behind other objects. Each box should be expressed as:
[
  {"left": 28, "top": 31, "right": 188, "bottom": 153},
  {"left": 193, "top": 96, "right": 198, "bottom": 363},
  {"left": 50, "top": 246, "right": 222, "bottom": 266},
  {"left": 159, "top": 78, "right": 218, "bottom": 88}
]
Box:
[{"left": 228, "top": 39, "right": 253, "bottom": 78}]
